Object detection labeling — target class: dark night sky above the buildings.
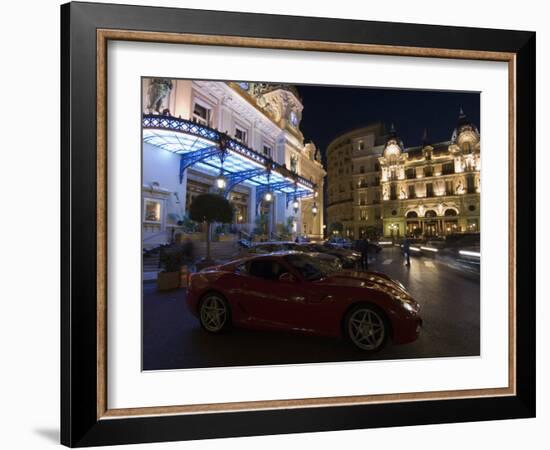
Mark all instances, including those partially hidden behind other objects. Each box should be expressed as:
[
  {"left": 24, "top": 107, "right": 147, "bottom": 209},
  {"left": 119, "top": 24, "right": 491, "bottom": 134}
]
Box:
[{"left": 296, "top": 85, "right": 480, "bottom": 159}]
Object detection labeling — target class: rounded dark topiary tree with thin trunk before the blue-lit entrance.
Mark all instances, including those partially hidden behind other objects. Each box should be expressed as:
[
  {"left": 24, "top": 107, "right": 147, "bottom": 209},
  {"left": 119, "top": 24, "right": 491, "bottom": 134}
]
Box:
[{"left": 189, "top": 193, "right": 233, "bottom": 264}]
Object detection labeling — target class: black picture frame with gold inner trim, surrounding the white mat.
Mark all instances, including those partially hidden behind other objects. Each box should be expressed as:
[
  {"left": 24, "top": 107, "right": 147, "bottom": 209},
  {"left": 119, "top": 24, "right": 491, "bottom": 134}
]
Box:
[{"left": 62, "top": 3, "right": 535, "bottom": 446}]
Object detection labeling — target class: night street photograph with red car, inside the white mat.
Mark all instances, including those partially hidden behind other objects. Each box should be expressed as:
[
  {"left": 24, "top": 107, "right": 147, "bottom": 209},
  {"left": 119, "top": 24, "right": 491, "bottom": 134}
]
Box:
[{"left": 142, "top": 76, "right": 484, "bottom": 371}]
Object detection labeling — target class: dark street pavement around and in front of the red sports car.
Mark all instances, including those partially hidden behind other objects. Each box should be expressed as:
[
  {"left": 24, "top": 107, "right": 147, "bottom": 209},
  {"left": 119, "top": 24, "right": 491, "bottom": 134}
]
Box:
[{"left": 143, "top": 248, "right": 480, "bottom": 370}]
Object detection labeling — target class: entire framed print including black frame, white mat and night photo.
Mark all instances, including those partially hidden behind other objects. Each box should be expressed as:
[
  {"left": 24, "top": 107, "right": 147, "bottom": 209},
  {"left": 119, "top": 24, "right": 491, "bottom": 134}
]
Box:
[{"left": 61, "top": 3, "right": 535, "bottom": 447}]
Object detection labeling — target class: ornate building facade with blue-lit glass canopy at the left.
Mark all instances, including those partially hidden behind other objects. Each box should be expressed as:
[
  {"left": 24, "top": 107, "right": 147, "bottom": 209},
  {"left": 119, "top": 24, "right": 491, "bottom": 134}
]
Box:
[{"left": 142, "top": 78, "right": 325, "bottom": 246}]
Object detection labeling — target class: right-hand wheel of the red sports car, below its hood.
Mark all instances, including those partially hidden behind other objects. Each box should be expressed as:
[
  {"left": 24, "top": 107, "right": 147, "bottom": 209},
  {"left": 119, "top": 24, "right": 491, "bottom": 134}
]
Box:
[{"left": 344, "top": 304, "right": 389, "bottom": 353}]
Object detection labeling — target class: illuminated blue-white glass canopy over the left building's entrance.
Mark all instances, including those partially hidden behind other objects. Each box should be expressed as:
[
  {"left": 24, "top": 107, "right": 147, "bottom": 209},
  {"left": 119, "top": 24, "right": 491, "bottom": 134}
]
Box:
[{"left": 142, "top": 114, "right": 315, "bottom": 197}]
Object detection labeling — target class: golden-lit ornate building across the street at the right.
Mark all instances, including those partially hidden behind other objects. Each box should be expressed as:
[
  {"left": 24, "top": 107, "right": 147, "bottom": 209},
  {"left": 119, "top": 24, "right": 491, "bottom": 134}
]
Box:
[{"left": 327, "top": 111, "right": 481, "bottom": 239}]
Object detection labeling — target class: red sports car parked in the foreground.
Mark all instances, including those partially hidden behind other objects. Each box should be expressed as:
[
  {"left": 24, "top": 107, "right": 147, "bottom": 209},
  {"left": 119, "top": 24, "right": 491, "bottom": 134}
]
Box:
[{"left": 187, "top": 252, "right": 422, "bottom": 352}]
